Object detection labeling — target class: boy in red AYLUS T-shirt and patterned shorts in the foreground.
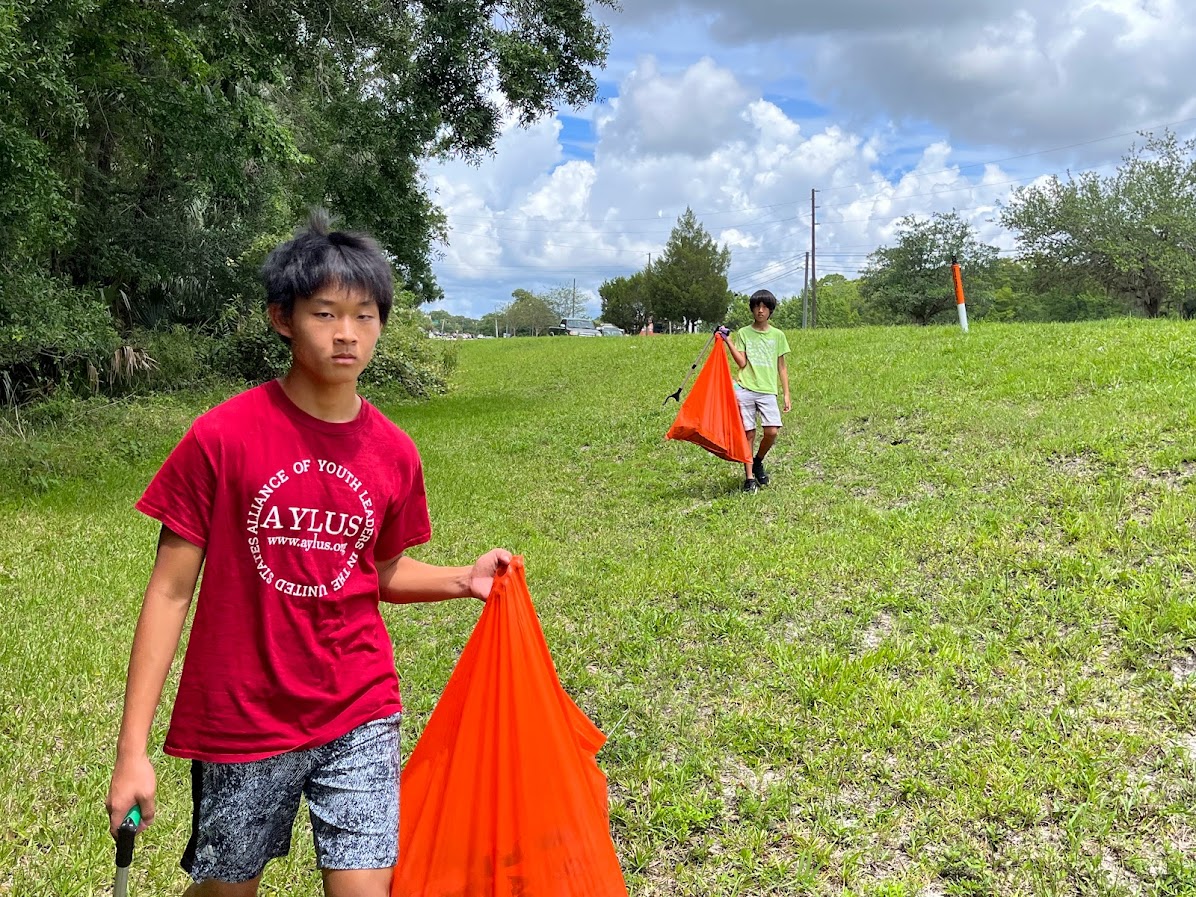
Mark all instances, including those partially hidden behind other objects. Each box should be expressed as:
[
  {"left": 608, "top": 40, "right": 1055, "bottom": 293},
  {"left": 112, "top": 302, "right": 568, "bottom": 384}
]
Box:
[{"left": 106, "top": 215, "right": 511, "bottom": 897}]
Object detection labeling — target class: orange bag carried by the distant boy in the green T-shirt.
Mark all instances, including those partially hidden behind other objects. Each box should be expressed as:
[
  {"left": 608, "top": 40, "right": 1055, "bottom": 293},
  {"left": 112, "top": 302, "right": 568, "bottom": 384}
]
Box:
[{"left": 665, "top": 340, "right": 751, "bottom": 464}]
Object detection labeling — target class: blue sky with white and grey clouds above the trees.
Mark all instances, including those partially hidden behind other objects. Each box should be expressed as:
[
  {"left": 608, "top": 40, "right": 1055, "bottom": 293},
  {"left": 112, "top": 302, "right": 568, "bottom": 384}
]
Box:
[{"left": 426, "top": 0, "right": 1196, "bottom": 317}]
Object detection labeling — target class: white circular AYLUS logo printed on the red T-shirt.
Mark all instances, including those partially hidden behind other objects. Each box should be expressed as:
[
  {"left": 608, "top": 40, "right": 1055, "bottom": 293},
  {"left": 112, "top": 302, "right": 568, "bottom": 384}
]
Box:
[{"left": 245, "top": 458, "right": 374, "bottom": 598}]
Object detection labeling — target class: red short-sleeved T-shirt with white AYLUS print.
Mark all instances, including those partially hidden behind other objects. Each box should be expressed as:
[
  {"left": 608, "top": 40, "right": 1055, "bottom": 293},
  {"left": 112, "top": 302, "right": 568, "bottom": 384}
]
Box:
[{"left": 136, "top": 380, "right": 432, "bottom": 762}]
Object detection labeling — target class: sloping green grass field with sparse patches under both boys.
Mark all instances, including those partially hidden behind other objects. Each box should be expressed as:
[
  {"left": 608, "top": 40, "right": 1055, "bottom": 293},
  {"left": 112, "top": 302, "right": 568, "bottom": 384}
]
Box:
[{"left": 0, "top": 321, "right": 1196, "bottom": 897}]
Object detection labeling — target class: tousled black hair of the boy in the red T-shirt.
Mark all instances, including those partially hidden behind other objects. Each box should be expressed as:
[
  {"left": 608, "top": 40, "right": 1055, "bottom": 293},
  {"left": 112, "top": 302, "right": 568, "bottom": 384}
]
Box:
[{"left": 262, "top": 208, "right": 395, "bottom": 334}]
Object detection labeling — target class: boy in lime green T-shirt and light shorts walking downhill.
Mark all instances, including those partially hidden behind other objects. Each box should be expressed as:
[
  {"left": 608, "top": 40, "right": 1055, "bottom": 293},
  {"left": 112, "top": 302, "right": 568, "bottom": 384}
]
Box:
[{"left": 719, "top": 289, "right": 793, "bottom": 492}]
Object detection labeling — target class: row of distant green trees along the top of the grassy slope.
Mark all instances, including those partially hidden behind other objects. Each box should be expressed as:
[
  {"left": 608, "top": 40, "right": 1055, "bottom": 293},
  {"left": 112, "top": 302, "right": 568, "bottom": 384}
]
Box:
[{"left": 599, "top": 132, "right": 1196, "bottom": 329}]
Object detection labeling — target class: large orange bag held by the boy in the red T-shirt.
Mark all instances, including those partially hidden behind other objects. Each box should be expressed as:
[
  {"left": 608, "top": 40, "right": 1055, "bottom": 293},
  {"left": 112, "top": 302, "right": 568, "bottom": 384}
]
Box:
[{"left": 391, "top": 557, "right": 627, "bottom": 897}]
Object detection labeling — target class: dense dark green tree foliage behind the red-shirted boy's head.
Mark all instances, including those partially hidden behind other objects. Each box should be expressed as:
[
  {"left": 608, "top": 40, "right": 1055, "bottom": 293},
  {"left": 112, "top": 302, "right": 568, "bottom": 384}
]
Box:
[{"left": 0, "top": 0, "right": 614, "bottom": 399}]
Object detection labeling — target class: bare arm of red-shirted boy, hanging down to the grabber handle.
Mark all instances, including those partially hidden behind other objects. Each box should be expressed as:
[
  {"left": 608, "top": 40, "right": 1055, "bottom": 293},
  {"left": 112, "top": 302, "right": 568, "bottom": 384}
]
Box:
[{"left": 104, "top": 526, "right": 203, "bottom": 832}]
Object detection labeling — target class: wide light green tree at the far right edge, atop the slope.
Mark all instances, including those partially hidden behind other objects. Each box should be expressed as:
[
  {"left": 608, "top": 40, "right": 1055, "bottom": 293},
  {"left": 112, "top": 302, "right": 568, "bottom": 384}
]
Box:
[{"left": 1001, "top": 132, "right": 1196, "bottom": 317}]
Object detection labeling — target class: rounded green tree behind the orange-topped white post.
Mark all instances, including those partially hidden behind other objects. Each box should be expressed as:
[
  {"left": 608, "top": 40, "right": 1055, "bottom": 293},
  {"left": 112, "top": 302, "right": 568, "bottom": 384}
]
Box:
[{"left": 861, "top": 212, "right": 997, "bottom": 324}]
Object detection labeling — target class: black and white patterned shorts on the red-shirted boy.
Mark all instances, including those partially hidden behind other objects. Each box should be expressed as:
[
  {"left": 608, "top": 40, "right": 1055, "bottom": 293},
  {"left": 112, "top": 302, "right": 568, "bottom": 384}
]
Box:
[{"left": 182, "top": 714, "right": 401, "bottom": 881}]
